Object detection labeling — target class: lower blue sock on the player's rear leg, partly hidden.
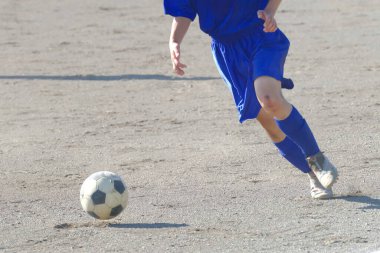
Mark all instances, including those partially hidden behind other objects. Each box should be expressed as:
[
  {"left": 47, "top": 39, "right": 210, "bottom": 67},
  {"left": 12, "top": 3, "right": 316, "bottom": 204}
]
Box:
[{"left": 274, "top": 137, "right": 311, "bottom": 173}]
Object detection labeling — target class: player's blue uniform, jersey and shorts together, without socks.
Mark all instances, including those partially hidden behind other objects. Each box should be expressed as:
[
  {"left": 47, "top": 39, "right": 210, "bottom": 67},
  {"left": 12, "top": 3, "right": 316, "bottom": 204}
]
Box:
[{"left": 164, "top": 0, "right": 293, "bottom": 122}]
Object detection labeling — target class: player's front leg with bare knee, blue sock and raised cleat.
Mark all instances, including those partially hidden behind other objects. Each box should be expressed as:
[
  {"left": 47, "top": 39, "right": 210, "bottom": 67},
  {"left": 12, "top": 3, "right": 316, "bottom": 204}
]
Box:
[{"left": 254, "top": 76, "right": 338, "bottom": 188}]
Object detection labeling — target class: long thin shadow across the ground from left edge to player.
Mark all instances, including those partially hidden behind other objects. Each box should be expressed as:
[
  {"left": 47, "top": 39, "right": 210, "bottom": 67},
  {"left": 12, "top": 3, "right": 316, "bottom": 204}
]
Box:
[{"left": 0, "top": 74, "right": 220, "bottom": 82}]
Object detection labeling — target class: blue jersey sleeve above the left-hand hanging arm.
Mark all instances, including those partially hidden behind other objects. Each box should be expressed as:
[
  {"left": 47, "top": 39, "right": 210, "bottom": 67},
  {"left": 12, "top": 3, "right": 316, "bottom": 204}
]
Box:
[{"left": 164, "top": 0, "right": 197, "bottom": 21}]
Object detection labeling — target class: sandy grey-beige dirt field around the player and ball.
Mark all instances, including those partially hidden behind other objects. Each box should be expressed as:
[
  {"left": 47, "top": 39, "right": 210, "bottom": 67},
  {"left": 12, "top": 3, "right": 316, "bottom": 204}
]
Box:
[{"left": 0, "top": 0, "right": 380, "bottom": 253}]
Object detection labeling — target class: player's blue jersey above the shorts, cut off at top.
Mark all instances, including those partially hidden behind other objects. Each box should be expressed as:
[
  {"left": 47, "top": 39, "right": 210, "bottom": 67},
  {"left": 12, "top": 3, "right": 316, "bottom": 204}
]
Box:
[{"left": 164, "top": 0, "right": 268, "bottom": 38}]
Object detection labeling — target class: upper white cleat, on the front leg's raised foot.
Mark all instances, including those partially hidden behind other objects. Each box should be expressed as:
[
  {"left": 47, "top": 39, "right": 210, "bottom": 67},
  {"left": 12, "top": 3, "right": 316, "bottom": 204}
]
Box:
[{"left": 307, "top": 152, "right": 338, "bottom": 189}]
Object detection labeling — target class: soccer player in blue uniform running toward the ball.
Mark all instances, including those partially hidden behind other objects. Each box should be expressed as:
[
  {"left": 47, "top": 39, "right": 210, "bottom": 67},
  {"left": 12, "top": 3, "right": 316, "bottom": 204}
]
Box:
[{"left": 164, "top": 0, "right": 338, "bottom": 199}]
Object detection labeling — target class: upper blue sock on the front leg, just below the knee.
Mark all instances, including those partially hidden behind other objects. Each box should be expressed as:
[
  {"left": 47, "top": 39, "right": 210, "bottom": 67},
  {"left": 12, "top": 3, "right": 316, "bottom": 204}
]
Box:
[{"left": 276, "top": 106, "right": 320, "bottom": 157}]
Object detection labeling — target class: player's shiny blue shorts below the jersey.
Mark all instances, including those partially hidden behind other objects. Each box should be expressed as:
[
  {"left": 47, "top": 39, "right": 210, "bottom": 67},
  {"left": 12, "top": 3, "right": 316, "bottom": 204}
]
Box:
[{"left": 211, "top": 26, "right": 290, "bottom": 122}]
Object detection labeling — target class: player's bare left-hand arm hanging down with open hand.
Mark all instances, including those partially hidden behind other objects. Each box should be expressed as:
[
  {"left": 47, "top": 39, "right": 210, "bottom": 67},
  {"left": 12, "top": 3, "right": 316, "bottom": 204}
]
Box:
[{"left": 169, "top": 17, "right": 191, "bottom": 76}]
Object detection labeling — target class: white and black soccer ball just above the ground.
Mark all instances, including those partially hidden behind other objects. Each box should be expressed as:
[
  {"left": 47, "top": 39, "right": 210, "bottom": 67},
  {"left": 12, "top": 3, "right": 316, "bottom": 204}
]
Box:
[{"left": 80, "top": 171, "right": 128, "bottom": 220}]
